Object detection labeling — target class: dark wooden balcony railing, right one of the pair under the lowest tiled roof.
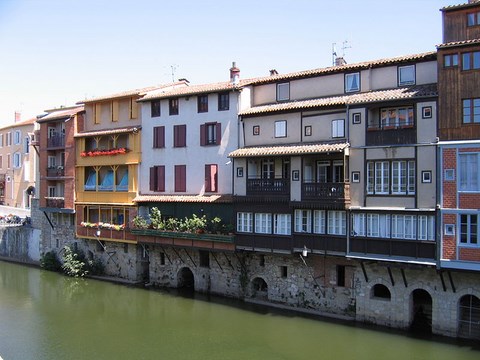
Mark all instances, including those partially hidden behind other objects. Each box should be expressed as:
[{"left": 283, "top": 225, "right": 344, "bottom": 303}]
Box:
[{"left": 302, "top": 182, "right": 350, "bottom": 206}]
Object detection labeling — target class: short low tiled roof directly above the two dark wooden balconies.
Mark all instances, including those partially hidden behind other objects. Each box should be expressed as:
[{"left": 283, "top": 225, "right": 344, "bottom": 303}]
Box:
[{"left": 228, "top": 143, "right": 349, "bottom": 158}]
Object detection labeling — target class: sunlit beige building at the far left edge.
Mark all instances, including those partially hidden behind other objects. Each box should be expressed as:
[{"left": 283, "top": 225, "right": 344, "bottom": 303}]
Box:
[{"left": 0, "top": 118, "right": 36, "bottom": 208}]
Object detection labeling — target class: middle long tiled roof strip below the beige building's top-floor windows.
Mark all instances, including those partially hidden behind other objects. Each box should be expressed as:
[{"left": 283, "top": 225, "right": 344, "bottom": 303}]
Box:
[{"left": 239, "top": 84, "right": 438, "bottom": 116}]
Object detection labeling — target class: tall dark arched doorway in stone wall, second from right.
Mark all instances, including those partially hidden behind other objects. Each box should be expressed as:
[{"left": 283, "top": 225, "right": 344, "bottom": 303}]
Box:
[{"left": 410, "top": 289, "right": 432, "bottom": 334}]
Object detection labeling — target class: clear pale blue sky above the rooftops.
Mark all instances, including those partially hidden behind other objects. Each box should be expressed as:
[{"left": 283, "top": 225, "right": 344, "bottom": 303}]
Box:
[{"left": 0, "top": 0, "right": 456, "bottom": 126}]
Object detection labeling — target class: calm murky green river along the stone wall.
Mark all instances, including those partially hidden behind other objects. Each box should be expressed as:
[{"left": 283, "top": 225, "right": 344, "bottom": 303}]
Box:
[{"left": 0, "top": 261, "right": 480, "bottom": 360}]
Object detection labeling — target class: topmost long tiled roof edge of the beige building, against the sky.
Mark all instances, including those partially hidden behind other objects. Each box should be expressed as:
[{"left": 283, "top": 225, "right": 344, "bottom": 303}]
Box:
[{"left": 242, "top": 51, "right": 437, "bottom": 85}]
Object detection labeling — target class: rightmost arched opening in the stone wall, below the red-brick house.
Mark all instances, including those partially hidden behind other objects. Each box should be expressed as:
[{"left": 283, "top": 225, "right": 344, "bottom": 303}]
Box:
[{"left": 458, "top": 295, "right": 480, "bottom": 339}]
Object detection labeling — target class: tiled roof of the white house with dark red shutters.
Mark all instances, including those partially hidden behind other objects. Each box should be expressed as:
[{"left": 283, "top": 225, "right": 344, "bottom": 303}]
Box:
[{"left": 138, "top": 80, "right": 246, "bottom": 101}]
